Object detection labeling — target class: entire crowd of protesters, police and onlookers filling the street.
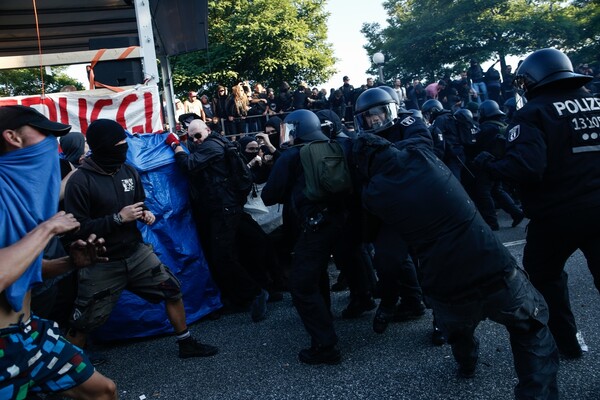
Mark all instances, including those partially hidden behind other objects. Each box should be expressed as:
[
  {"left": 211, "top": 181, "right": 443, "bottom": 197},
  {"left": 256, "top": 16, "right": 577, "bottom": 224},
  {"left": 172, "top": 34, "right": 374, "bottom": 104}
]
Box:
[{"left": 0, "top": 49, "right": 600, "bottom": 399}]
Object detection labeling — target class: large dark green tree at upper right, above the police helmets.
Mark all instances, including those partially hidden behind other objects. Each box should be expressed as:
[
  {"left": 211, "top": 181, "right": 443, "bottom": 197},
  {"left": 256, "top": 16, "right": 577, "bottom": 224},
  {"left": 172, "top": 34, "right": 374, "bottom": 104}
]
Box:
[{"left": 362, "top": 0, "right": 598, "bottom": 80}]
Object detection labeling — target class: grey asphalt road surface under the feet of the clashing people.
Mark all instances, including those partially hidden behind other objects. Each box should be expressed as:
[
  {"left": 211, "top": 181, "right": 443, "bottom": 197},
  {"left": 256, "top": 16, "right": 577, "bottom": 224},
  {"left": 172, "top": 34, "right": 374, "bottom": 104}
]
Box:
[{"left": 98, "top": 214, "right": 600, "bottom": 400}]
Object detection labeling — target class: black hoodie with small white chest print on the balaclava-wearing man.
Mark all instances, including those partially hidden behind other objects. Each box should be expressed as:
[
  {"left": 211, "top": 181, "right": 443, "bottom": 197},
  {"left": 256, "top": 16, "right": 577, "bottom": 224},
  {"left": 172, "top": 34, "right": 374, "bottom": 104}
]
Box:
[{"left": 64, "top": 158, "right": 146, "bottom": 259}]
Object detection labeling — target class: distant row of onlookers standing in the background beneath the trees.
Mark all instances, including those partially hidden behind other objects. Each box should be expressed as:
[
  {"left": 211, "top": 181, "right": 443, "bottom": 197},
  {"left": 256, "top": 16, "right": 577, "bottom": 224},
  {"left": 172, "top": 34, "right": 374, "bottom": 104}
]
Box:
[{"left": 175, "top": 59, "right": 600, "bottom": 141}]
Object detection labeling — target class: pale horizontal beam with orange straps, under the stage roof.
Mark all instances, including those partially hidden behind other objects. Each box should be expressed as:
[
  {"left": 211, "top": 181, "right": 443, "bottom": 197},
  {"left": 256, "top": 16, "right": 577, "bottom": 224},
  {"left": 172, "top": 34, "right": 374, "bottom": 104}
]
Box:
[{"left": 0, "top": 47, "right": 141, "bottom": 69}]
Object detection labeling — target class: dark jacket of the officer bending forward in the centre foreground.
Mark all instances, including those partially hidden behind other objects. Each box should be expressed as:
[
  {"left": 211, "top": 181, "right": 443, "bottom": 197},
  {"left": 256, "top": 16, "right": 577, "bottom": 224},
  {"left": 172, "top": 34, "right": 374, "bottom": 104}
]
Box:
[{"left": 353, "top": 134, "right": 515, "bottom": 300}]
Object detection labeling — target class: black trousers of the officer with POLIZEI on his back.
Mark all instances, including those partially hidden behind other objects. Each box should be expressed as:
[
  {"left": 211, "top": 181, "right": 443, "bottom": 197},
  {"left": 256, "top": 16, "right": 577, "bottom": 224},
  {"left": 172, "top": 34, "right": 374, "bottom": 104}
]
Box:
[{"left": 523, "top": 209, "right": 600, "bottom": 349}]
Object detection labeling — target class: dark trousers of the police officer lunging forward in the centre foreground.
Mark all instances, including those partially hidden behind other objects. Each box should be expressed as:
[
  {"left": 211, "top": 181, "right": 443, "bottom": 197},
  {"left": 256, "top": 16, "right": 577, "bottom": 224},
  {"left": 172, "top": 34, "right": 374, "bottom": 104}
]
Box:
[{"left": 429, "top": 270, "right": 558, "bottom": 400}]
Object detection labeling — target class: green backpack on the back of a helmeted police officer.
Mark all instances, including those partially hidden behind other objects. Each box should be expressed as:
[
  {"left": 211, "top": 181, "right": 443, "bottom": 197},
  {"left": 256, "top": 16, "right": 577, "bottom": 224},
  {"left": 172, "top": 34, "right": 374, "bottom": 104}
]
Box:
[{"left": 300, "top": 140, "right": 352, "bottom": 202}]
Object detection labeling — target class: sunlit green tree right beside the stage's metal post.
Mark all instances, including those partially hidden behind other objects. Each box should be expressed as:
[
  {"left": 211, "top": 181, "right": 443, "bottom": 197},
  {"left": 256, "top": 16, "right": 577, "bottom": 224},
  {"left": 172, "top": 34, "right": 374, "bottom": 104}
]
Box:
[{"left": 171, "top": 0, "right": 335, "bottom": 95}]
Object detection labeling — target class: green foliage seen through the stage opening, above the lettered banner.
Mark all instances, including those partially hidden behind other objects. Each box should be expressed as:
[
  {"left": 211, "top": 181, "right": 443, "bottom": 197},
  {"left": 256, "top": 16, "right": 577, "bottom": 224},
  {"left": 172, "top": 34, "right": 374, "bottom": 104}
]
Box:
[{"left": 0, "top": 67, "right": 84, "bottom": 97}]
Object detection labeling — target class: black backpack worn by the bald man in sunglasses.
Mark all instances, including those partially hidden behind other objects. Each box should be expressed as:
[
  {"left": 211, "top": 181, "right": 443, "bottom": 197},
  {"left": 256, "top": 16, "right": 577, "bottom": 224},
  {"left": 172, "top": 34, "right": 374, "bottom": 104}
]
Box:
[{"left": 209, "top": 136, "right": 253, "bottom": 203}]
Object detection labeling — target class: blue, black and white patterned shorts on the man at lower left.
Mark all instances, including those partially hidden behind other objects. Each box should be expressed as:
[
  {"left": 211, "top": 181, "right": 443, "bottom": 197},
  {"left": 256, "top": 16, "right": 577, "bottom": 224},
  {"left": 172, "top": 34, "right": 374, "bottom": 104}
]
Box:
[{"left": 0, "top": 316, "right": 94, "bottom": 400}]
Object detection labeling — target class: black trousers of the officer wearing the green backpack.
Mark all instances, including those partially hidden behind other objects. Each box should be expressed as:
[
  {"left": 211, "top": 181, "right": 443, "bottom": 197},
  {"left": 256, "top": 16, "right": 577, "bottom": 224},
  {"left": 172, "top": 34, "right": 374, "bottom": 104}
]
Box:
[{"left": 289, "top": 214, "right": 344, "bottom": 346}]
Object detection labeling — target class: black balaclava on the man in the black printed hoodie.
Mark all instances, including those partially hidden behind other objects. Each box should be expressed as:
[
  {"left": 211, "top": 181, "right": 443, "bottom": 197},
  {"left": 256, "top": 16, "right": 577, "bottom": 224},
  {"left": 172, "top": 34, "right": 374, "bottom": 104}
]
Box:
[{"left": 86, "top": 119, "right": 127, "bottom": 173}]
